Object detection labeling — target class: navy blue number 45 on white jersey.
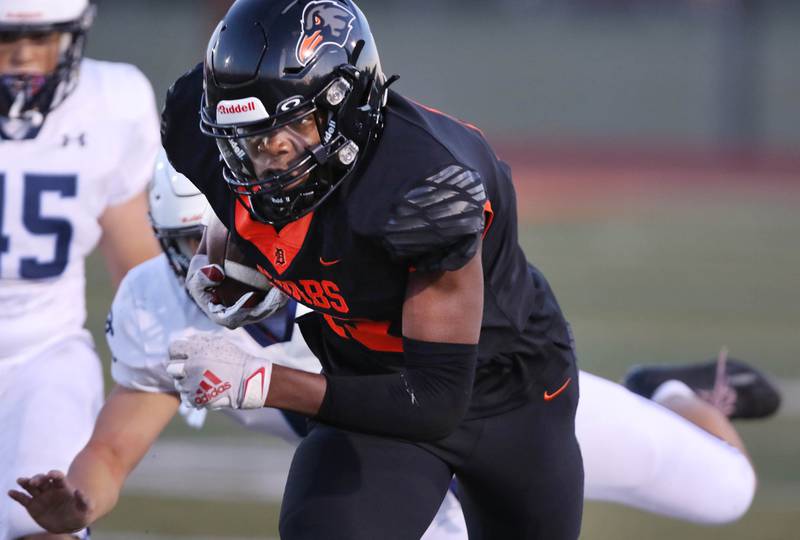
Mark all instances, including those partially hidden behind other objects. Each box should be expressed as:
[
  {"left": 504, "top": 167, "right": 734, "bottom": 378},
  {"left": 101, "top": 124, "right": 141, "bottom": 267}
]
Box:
[{"left": 0, "top": 174, "right": 78, "bottom": 279}]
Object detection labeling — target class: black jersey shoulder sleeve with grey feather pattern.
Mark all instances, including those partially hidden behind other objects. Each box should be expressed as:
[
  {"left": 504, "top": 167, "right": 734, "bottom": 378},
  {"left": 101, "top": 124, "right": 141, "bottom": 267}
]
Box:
[{"left": 382, "top": 165, "right": 486, "bottom": 271}]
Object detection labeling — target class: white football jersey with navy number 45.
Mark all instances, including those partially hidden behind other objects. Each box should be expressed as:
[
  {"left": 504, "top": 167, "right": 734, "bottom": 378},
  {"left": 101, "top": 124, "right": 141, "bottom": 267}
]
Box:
[{"left": 0, "top": 59, "right": 159, "bottom": 361}]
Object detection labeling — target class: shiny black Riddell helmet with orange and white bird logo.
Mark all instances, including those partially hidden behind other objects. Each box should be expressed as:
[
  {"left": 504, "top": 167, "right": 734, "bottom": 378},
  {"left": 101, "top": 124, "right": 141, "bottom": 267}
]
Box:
[{"left": 201, "top": 0, "right": 394, "bottom": 226}]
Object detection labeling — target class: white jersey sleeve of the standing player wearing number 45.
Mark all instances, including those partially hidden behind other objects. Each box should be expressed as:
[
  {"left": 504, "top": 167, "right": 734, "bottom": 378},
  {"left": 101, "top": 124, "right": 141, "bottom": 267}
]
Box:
[{"left": 104, "top": 64, "right": 161, "bottom": 206}]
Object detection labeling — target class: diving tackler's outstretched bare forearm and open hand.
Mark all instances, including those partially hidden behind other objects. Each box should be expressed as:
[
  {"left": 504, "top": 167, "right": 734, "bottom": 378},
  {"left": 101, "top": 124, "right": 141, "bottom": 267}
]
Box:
[{"left": 9, "top": 385, "right": 179, "bottom": 533}]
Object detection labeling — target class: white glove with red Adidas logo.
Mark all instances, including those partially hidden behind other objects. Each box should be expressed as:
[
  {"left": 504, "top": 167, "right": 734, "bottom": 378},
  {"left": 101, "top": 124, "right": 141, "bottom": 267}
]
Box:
[{"left": 167, "top": 335, "right": 272, "bottom": 409}]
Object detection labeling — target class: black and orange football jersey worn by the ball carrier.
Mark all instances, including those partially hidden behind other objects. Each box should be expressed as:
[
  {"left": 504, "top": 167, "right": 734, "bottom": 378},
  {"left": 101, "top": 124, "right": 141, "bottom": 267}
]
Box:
[{"left": 164, "top": 67, "right": 571, "bottom": 417}]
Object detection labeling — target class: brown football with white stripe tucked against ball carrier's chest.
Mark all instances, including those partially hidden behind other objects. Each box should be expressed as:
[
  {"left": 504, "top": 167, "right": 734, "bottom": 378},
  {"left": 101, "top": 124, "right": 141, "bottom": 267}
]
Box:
[{"left": 204, "top": 217, "right": 271, "bottom": 307}]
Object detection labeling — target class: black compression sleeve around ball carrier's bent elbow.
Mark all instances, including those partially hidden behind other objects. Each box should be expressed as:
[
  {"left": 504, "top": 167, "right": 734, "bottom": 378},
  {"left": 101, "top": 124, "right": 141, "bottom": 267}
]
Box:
[{"left": 317, "top": 338, "right": 478, "bottom": 441}]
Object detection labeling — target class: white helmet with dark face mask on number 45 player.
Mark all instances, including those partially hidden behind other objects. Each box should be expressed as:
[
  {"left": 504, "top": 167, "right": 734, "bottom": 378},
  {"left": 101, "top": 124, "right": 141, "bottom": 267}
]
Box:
[{"left": 0, "top": 0, "right": 95, "bottom": 139}]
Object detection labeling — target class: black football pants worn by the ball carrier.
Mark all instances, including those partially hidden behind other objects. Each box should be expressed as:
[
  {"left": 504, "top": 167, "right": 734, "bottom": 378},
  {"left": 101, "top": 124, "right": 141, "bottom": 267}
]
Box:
[{"left": 280, "top": 356, "right": 583, "bottom": 540}]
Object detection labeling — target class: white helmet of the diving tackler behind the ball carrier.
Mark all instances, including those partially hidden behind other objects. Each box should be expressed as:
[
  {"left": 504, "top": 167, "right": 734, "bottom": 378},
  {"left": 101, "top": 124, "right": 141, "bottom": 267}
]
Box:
[{"left": 148, "top": 148, "right": 209, "bottom": 278}]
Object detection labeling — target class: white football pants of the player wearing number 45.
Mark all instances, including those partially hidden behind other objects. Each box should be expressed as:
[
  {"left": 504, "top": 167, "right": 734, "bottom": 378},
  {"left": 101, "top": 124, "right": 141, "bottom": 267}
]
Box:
[{"left": 0, "top": 336, "right": 103, "bottom": 540}]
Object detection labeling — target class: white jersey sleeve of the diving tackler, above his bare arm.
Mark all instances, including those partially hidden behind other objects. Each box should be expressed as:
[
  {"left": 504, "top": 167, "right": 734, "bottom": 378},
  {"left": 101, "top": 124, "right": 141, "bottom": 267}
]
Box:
[{"left": 106, "top": 273, "right": 175, "bottom": 392}]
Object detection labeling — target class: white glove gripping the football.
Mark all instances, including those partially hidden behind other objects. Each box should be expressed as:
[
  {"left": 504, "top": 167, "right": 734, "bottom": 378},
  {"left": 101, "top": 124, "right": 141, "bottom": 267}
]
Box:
[{"left": 186, "top": 253, "right": 288, "bottom": 329}]
